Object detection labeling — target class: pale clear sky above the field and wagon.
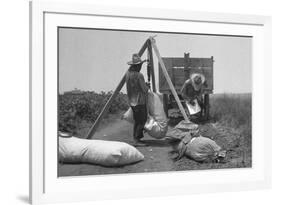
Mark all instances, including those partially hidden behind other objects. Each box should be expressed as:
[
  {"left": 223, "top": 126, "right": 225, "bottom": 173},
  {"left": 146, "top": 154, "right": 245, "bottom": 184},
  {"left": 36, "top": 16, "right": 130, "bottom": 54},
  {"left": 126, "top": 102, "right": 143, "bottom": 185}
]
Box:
[{"left": 58, "top": 28, "right": 252, "bottom": 93}]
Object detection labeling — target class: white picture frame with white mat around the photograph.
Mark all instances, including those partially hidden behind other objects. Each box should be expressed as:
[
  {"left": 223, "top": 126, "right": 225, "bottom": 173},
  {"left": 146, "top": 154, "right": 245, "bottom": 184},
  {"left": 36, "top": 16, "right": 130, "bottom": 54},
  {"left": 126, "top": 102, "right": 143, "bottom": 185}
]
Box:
[{"left": 30, "top": 1, "right": 271, "bottom": 204}]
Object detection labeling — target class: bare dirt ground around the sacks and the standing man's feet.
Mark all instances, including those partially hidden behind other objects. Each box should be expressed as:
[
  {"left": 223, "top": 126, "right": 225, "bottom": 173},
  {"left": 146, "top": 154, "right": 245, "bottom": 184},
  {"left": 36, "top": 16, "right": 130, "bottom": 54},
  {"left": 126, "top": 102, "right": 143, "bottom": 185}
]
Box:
[{"left": 58, "top": 117, "right": 251, "bottom": 176}]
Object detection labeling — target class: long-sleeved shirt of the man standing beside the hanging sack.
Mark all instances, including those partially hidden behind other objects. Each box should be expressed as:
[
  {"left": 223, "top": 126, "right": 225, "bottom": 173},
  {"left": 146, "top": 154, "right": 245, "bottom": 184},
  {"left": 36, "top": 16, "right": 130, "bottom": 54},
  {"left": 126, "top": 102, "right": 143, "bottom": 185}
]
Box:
[{"left": 126, "top": 71, "right": 148, "bottom": 106}]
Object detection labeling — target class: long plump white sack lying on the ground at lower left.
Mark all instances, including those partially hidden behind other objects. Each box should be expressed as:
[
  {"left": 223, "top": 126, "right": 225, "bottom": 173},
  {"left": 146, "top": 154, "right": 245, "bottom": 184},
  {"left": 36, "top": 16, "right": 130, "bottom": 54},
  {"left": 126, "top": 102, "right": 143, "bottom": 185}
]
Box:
[{"left": 59, "top": 137, "right": 144, "bottom": 166}]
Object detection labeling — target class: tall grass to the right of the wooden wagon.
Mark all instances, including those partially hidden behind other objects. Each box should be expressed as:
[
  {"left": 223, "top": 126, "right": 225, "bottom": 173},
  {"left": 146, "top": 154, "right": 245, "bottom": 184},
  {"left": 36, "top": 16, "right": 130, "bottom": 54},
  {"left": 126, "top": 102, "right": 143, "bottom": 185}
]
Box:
[{"left": 210, "top": 93, "right": 252, "bottom": 167}]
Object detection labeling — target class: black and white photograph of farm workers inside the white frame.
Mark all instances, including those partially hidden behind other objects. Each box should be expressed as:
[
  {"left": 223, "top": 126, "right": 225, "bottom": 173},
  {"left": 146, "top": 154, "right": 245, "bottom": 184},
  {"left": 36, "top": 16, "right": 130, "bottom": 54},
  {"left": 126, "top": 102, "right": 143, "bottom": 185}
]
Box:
[{"left": 57, "top": 27, "right": 252, "bottom": 177}]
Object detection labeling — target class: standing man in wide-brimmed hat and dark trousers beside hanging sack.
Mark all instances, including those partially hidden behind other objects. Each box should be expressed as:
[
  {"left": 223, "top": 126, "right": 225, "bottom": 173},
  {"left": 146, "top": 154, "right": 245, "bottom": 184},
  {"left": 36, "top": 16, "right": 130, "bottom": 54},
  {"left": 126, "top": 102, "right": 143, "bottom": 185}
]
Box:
[{"left": 126, "top": 54, "right": 149, "bottom": 146}]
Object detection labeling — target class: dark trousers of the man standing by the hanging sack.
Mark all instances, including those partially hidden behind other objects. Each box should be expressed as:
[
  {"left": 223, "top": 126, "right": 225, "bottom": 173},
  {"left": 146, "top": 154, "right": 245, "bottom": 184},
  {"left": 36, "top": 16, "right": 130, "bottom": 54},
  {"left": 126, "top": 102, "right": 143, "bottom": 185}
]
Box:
[{"left": 131, "top": 105, "right": 147, "bottom": 140}]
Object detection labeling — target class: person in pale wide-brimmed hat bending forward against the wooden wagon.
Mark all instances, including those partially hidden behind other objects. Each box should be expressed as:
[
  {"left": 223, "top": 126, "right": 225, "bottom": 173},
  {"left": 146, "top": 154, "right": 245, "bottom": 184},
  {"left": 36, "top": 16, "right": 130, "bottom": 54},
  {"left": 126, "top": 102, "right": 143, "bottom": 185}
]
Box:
[{"left": 181, "top": 73, "right": 207, "bottom": 106}]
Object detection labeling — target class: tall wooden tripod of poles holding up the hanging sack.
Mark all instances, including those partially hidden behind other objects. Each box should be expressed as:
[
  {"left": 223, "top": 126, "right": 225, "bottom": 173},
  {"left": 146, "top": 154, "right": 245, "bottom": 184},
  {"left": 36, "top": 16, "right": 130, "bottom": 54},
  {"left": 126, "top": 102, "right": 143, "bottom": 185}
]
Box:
[{"left": 86, "top": 37, "right": 189, "bottom": 139}]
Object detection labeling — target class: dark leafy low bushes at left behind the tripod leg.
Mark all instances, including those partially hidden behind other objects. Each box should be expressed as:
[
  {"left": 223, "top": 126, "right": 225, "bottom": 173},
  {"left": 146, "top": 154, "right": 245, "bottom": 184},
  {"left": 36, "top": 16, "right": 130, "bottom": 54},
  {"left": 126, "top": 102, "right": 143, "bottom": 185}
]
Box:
[{"left": 58, "top": 91, "right": 128, "bottom": 133}]
